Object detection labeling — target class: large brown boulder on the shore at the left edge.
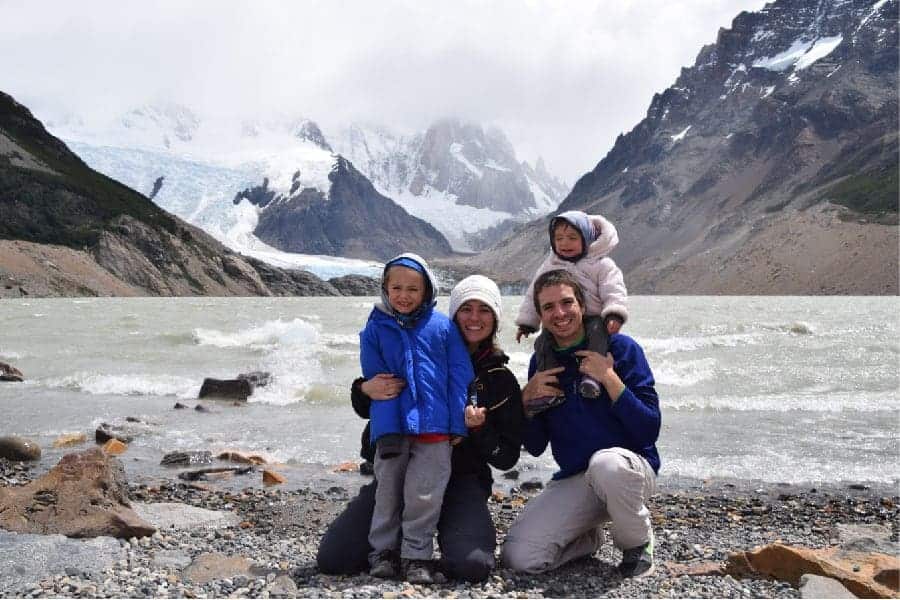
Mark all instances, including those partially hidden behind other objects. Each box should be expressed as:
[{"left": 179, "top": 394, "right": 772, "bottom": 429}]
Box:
[{"left": 0, "top": 448, "right": 156, "bottom": 538}]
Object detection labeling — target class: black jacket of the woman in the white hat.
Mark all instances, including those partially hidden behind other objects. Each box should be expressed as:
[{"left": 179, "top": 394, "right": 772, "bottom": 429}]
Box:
[{"left": 350, "top": 347, "right": 524, "bottom": 489}]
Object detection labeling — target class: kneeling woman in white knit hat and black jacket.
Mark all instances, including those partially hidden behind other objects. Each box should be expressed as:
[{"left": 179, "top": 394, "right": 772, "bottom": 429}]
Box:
[{"left": 316, "top": 275, "right": 523, "bottom": 582}]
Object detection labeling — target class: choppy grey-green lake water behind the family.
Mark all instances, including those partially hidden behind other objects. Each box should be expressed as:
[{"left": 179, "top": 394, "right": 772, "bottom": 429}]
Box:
[{"left": 0, "top": 296, "right": 900, "bottom": 483}]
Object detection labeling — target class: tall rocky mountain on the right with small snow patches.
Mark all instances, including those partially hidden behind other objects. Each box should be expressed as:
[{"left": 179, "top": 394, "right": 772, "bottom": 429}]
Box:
[{"left": 458, "top": 0, "right": 898, "bottom": 294}]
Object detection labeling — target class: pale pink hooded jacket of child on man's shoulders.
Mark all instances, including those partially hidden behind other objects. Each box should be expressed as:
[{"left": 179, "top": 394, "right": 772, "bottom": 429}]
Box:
[{"left": 516, "top": 215, "right": 628, "bottom": 331}]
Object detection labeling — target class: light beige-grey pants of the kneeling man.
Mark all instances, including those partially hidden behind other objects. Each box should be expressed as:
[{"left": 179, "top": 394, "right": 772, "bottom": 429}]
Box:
[{"left": 500, "top": 448, "right": 656, "bottom": 573}]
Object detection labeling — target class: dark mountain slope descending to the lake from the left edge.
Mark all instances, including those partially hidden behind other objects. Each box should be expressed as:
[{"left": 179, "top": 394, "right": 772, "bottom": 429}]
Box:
[{"left": 0, "top": 92, "right": 366, "bottom": 297}]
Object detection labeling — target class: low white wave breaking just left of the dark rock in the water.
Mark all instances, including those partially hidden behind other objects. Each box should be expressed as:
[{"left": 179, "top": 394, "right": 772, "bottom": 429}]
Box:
[{"left": 41, "top": 372, "right": 200, "bottom": 398}]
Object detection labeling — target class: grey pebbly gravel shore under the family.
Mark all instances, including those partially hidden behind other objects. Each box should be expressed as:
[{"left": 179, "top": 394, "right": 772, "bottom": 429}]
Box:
[{"left": 0, "top": 461, "right": 900, "bottom": 598}]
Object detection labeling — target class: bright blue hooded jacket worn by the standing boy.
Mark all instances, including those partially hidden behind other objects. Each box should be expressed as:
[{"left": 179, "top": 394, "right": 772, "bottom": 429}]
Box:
[{"left": 359, "top": 253, "right": 475, "bottom": 442}]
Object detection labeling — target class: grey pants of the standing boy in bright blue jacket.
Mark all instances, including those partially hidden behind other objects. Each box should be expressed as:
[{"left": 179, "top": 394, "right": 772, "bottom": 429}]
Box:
[{"left": 369, "top": 436, "right": 451, "bottom": 563}]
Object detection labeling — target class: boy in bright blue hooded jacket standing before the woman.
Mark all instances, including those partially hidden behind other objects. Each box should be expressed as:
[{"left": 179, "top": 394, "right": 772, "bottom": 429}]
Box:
[{"left": 360, "top": 253, "right": 474, "bottom": 583}]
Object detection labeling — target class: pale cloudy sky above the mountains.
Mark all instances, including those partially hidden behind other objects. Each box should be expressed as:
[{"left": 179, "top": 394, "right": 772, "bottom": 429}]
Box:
[{"left": 0, "top": 0, "right": 764, "bottom": 184}]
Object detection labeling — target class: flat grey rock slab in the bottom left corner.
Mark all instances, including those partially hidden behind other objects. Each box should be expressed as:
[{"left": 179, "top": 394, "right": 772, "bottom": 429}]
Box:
[{"left": 0, "top": 530, "right": 126, "bottom": 596}]
